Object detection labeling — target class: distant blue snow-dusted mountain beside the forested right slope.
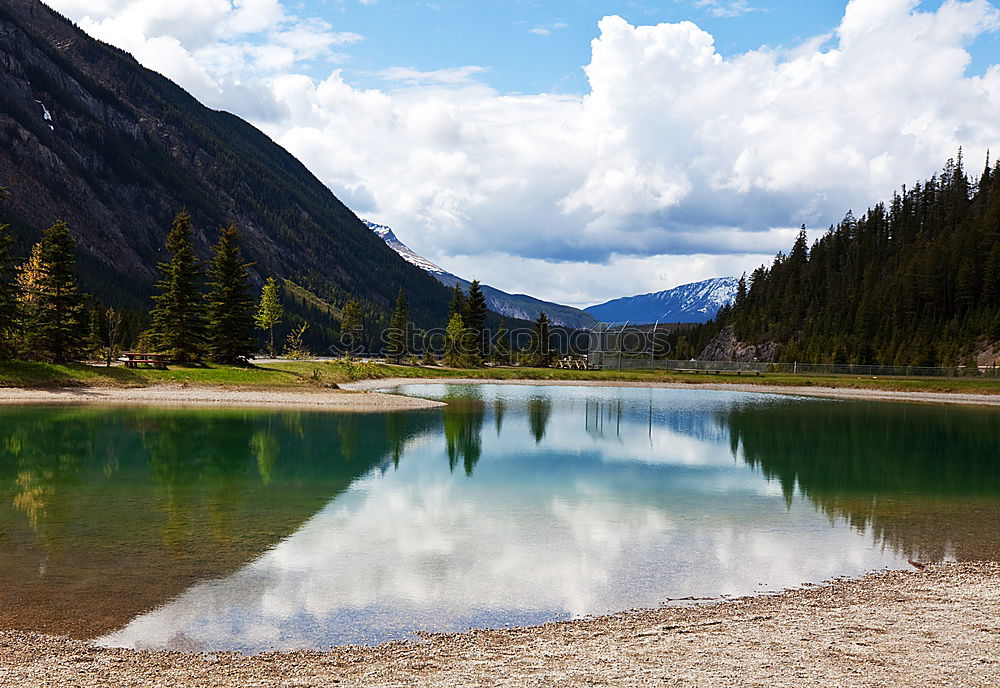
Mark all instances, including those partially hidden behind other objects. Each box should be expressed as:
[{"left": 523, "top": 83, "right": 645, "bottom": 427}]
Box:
[{"left": 584, "top": 277, "right": 739, "bottom": 324}]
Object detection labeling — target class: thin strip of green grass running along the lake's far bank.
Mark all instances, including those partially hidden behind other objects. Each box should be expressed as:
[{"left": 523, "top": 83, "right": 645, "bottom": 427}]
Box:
[{"left": 0, "top": 361, "right": 1000, "bottom": 394}]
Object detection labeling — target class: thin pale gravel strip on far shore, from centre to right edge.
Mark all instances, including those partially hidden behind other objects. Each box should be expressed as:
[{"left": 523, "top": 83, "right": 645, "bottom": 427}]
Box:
[{"left": 341, "top": 378, "right": 1000, "bottom": 406}]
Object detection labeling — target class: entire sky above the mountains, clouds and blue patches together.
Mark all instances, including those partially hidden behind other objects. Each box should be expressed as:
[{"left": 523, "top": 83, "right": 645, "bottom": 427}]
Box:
[{"left": 49, "top": 0, "right": 1000, "bottom": 305}]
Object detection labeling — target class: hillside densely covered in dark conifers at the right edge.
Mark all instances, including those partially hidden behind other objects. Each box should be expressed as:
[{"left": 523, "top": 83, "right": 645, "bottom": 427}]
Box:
[{"left": 680, "top": 152, "right": 1000, "bottom": 366}]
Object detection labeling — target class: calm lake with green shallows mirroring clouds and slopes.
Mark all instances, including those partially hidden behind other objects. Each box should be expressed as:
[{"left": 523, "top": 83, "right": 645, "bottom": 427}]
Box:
[{"left": 0, "top": 385, "right": 1000, "bottom": 653}]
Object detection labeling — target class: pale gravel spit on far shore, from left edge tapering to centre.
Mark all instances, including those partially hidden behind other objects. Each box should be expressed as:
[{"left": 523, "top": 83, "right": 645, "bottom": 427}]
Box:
[{"left": 0, "top": 385, "right": 443, "bottom": 412}]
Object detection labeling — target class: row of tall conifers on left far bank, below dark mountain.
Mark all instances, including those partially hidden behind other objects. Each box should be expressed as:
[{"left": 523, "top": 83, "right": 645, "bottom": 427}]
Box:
[{"left": 0, "top": 200, "right": 283, "bottom": 365}]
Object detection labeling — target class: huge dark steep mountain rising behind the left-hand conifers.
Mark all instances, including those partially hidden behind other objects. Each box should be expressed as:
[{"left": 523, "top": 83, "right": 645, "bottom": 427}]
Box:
[{"left": 0, "top": 0, "right": 449, "bottom": 324}]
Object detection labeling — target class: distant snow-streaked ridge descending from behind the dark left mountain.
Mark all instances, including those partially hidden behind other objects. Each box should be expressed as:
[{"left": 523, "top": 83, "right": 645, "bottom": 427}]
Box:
[{"left": 372, "top": 220, "right": 597, "bottom": 329}]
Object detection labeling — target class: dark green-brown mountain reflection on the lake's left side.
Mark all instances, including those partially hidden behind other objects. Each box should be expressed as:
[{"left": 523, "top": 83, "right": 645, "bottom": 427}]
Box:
[{"left": 0, "top": 407, "right": 436, "bottom": 637}]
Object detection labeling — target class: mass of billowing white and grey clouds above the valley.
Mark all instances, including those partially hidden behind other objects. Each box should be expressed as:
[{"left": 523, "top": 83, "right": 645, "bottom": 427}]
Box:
[{"left": 48, "top": 0, "right": 1000, "bottom": 303}]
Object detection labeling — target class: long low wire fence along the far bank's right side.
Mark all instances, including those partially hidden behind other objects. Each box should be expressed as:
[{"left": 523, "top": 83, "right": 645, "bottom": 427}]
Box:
[{"left": 588, "top": 352, "right": 1000, "bottom": 378}]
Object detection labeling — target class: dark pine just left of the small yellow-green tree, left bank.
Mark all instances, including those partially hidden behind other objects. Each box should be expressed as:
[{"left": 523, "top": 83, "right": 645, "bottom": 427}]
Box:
[{"left": 208, "top": 224, "right": 257, "bottom": 363}]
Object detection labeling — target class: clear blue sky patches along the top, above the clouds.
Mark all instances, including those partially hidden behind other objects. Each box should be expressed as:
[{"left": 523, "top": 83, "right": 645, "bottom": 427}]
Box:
[{"left": 306, "top": 0, "right": 1000, "bottom": 93}]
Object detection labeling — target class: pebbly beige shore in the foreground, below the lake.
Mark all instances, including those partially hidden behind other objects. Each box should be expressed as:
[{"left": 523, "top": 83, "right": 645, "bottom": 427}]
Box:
[{"left": 0, "top": 563, "right": 1000, "bottom": 688}]
